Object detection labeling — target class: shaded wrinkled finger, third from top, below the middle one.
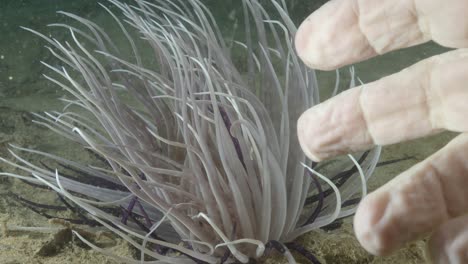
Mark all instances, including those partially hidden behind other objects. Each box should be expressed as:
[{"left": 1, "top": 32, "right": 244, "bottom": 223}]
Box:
[{"left": 354, "top": 134, "right": 468, "bottom": 255}]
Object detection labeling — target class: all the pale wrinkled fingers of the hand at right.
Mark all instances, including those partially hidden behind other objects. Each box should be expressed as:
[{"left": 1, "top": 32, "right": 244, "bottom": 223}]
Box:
[{"left": 296, "top": 0, "right": 468, "bottom": 263}]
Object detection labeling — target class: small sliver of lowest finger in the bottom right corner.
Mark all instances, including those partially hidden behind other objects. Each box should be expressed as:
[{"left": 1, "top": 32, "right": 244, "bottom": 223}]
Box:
[{"left": 428, "top": 215, "right": 468, "bottom": 264}]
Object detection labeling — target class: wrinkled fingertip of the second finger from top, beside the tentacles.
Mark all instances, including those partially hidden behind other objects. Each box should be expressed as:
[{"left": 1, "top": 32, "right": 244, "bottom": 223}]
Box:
[{"left": 297, "top": 89, "right": 373, "bottom": 161}]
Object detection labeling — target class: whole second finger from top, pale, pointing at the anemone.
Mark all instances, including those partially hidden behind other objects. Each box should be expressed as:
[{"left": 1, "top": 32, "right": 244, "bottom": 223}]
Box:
[{"left": 297, "top": 50, "right": 468, "bottom": 161}]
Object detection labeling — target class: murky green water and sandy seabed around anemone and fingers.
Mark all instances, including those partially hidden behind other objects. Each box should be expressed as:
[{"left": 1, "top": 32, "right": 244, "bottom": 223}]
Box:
[{"left": 0, "top": 0, "right": 454, "bottom": 264}]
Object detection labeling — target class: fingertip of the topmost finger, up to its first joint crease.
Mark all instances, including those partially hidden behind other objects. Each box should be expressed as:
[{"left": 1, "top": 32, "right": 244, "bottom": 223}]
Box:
[{"left": 295, "top": 0, "right": 377, "bottom": 71}]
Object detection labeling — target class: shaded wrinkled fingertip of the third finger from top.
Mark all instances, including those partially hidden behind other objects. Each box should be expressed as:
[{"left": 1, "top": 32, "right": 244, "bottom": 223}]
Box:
[{"left": 354, "top": 157, "right": 454, "bottom": 256}]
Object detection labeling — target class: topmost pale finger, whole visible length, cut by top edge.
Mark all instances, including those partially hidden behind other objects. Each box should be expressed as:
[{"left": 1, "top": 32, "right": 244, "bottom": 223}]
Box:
[{"left": 295, "top": 0, "right": 468, "bottom": 70}]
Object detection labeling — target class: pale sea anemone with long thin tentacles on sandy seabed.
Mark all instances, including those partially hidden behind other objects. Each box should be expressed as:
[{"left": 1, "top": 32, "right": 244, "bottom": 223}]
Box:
[{"left": 2, "top": 0, "right": 380, "bottom": 263}]
